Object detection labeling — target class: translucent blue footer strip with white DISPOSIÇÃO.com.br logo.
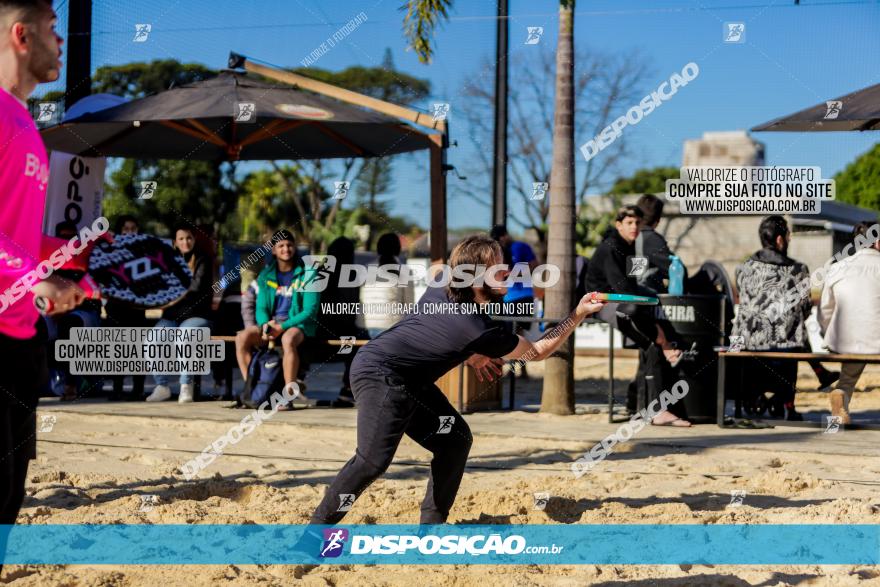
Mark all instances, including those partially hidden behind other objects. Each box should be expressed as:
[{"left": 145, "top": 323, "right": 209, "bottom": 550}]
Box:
[{"left": 0, "top": 524, "right": 880, "bottom": 565}]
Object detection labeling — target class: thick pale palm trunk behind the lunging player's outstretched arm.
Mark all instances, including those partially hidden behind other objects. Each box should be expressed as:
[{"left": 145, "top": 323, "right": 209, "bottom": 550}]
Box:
[{"left": 541, "top": 0, "right": 576, "bottom": 414}]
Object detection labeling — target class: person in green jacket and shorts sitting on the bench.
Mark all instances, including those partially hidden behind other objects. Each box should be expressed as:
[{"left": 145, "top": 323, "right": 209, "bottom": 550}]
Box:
[{"left": 235, "top": 229, "right": 320, "bottom": 400}]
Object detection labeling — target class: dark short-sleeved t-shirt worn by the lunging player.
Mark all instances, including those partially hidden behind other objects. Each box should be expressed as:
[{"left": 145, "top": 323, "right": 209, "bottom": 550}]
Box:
[{"left": 351, "top": 287, "right": 519, "bottom": 383}]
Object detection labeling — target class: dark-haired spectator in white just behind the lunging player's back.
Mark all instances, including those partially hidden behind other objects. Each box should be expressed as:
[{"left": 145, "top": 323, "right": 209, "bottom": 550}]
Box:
[{"left": 361, "top": 232, "right": 415, "bottom": 337}]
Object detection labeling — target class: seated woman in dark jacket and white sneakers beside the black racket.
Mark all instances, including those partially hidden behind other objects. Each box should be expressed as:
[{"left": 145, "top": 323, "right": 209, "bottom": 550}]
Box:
[{"left": 147, "top": 226, "right": 214, "bottom": 404}]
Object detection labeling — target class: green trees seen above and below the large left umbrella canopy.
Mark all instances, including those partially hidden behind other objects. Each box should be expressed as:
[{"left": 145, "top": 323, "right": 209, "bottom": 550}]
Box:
[{"left": 42, "top": 51, "right": 430, "bottom": 250}]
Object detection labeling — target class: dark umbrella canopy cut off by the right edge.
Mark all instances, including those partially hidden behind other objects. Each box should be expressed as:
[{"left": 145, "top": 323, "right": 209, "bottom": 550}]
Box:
[{"left": 752, "top": 84, "right": 880, "bottom": 132}]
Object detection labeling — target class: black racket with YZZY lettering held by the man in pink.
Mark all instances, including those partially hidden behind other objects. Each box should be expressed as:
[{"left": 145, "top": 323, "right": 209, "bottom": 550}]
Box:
[{"left": 34, "top": 234, "right": 192, "bottom": 313}]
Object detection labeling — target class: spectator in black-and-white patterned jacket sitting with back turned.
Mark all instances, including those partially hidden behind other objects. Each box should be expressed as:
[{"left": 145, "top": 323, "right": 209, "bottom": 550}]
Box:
[{"left": 731, "top": 215, "right": 811, "bottom": 420}]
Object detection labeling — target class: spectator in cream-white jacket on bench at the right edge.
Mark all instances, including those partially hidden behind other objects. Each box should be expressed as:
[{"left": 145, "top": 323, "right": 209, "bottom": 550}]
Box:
[{"left": 818, "top": 222, "right": 880, "bottom": 424}]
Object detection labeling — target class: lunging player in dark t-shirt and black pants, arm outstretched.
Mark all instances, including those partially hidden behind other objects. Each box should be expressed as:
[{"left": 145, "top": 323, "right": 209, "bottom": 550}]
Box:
[{"left": 311, "top": 236, "right": 602, "bottom": 524}]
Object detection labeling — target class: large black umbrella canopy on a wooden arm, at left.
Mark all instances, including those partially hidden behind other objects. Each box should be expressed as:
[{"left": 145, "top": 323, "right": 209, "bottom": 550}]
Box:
[{"left": 42, "top": 71, "right": 429, "bottom": 161}]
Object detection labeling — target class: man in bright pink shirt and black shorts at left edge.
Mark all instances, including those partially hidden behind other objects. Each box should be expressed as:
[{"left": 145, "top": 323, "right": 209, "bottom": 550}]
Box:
[{"left": 0, "top": 0, "right": 84, "bottom": 572}]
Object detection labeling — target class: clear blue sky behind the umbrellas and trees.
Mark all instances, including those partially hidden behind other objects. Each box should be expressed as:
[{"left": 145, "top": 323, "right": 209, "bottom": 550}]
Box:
[{"left": 47, "top": 0, "right": 880, "bottom": 233}]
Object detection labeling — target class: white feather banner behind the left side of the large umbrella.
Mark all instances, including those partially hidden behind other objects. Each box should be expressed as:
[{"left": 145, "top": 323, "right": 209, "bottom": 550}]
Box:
[{"left": 43, "top": 94, "right": 125, "bottom": 236}]
